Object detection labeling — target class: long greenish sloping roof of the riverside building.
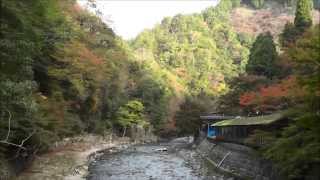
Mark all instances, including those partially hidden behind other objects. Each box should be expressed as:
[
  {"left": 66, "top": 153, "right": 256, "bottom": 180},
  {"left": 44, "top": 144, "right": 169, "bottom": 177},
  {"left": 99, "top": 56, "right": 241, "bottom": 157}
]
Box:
[{"left": 211, "top": 113, "right": 283, "bottom": 127}]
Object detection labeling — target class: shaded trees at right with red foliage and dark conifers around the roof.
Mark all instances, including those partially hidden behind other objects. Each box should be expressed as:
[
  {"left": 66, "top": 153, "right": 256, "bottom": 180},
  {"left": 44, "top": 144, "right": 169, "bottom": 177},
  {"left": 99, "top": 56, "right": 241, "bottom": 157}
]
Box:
[{"left": 219, "top": 0, "right": 320, "bottom": 179}]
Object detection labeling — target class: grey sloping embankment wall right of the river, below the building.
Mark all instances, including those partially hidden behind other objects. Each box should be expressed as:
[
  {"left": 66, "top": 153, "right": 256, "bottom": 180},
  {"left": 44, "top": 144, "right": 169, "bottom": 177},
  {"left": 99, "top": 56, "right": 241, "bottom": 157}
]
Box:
[{"left": 196, "top": 138, "right": 280, "bottom": 180}]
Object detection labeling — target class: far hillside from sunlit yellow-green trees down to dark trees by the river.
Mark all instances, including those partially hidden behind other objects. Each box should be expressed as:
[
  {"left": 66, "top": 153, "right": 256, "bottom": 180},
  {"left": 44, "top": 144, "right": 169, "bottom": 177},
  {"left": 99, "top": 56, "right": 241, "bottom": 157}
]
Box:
[{"left": 130, "top": 1, "right": 253, "bottom": 135}]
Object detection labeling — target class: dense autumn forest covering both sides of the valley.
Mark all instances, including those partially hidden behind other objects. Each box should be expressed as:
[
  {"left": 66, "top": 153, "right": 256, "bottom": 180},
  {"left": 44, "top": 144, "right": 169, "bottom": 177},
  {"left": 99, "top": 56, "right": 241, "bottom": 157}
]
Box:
[{"left": 0, "top": 0, "right": 320, "bottom": 179}]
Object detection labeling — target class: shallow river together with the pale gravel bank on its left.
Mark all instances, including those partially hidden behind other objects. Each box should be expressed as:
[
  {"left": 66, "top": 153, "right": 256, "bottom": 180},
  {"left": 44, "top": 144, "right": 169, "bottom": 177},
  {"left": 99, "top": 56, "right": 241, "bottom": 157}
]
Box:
[{"left": 16, "top": 135, "right": 237, "bottom": 180}]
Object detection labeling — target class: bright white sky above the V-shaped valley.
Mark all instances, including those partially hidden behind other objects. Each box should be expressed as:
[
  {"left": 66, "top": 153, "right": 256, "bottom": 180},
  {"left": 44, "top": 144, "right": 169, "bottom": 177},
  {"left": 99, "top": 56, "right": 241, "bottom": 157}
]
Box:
[{"left": 78, "top": 0, "right": 218, "bottom": 40}]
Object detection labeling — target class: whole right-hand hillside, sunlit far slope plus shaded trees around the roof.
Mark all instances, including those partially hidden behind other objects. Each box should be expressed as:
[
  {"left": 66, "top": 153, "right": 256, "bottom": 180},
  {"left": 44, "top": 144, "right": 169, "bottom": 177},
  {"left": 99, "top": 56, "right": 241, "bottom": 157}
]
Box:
[{"left": 131, "top": 0, "right": 320, "bottom": 179}]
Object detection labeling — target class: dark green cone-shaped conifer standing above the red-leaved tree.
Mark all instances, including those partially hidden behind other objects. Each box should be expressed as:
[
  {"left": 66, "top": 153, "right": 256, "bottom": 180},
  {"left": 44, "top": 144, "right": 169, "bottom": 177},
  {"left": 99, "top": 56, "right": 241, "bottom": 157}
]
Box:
[{"left": 246, "top": 32, "right": 278, "bottom": 78}]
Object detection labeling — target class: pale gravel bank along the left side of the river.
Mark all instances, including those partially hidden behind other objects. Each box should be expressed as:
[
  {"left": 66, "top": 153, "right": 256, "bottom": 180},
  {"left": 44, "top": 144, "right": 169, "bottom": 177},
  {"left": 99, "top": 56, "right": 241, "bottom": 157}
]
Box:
[{"left": 15, "top": 134, "right": 137, "bottom": 180}]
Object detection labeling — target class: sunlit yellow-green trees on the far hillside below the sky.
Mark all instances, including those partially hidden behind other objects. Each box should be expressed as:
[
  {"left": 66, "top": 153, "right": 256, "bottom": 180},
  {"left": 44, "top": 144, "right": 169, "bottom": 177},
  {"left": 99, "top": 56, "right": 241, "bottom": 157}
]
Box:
[{"left": 131, "top": 0, "right": 248, "bottom": 96}]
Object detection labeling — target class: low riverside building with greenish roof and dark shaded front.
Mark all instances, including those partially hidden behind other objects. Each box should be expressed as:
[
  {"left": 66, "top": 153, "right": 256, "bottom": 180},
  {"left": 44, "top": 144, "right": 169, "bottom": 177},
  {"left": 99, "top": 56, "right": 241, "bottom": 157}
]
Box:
[{"left": 211, "top": 113, "right": 288, "bottom": 144}]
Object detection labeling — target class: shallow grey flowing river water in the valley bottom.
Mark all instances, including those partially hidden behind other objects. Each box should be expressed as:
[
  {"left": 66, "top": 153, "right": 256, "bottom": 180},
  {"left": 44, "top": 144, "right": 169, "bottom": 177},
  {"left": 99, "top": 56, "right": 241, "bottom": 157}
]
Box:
[{"left": 87, "top": 141, "right": 235, "bottom": 180}]
